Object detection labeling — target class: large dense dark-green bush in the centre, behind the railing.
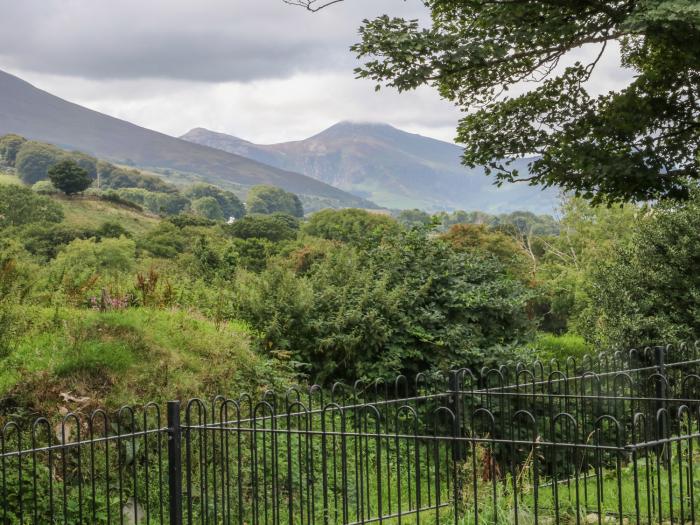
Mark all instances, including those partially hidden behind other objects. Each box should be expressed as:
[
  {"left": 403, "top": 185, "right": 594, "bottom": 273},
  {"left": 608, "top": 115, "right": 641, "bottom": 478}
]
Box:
[{"left": 236, "top": 230, "right": 532, "bottom": 379}]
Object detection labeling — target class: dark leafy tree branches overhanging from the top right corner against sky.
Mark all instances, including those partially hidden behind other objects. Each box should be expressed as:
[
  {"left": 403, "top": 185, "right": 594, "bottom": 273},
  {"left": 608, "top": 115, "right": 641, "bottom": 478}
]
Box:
[{"left": 286, "top": 0, "right": 700, "bottom": 202}]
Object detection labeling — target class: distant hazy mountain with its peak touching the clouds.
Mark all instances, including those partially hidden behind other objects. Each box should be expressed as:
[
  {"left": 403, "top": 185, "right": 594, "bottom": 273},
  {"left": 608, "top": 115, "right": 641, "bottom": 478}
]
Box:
[{"left": 181, "top": 122, "right": 557, "bottom": 213}]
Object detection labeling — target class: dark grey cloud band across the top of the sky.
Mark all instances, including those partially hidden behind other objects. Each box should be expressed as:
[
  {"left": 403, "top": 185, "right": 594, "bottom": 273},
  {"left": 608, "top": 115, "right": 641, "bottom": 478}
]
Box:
[{"left": 0, "top": 0, "right": 424, "bottom": 82}]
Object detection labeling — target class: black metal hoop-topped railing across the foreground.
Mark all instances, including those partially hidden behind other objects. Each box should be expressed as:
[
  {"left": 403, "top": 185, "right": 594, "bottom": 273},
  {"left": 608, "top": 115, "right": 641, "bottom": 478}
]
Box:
[{"left": 0, "top": 345, "right": 700, "bottom": 525}]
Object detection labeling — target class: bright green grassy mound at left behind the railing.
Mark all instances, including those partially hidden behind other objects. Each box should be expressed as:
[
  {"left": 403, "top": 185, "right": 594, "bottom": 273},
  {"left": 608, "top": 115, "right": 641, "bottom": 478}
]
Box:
[{"left": 0, "top": 307, "right": 284, "bottom": 415}]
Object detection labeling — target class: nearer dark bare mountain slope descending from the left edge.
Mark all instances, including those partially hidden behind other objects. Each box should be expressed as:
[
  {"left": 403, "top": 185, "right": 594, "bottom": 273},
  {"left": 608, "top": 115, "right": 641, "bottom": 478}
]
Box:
[{"left": 0, "top": 71, "right": 372, "bottom": 207}]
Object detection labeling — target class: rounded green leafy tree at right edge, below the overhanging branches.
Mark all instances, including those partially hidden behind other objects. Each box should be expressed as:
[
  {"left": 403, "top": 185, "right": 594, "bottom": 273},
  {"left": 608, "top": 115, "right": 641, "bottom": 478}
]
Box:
[{"left": 581, "top": 189, "right": 700, "bottom": 348}]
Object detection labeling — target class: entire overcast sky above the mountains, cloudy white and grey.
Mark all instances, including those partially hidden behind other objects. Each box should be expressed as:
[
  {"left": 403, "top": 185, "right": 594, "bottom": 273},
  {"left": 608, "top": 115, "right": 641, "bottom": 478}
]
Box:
[{"left": 0, "top": 0, "right": 629, "bottom": 143}]
